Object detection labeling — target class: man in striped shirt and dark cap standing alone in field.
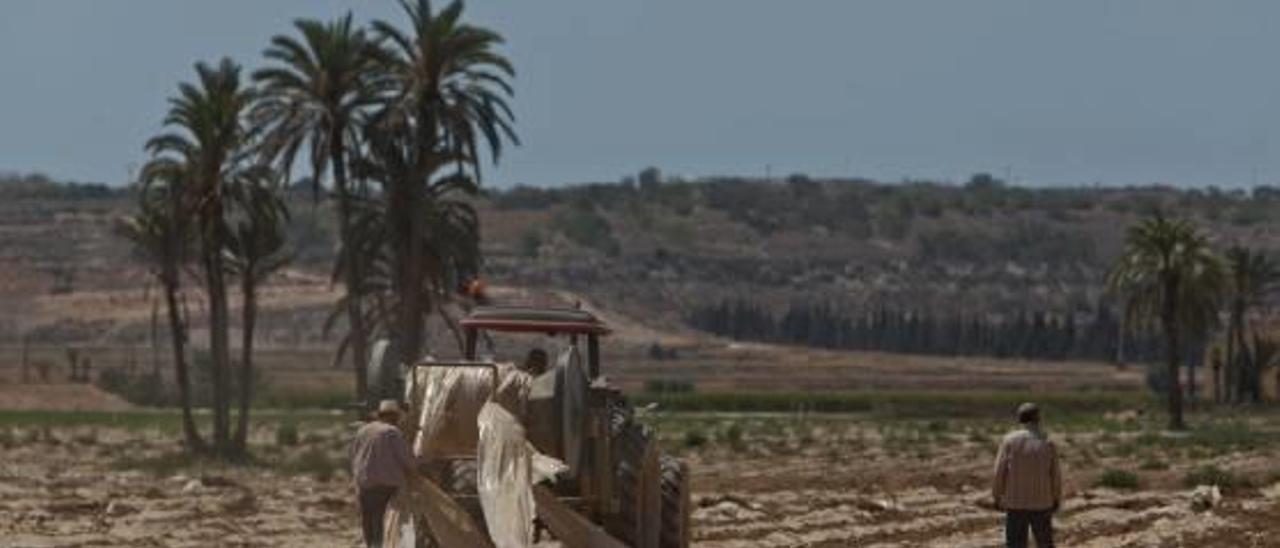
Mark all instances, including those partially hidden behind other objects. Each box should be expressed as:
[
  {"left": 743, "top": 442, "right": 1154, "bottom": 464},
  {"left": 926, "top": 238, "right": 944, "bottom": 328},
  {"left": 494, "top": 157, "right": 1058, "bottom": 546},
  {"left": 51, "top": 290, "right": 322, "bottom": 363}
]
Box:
[{"left": 992, "top": 403, "right": 1062, "bottom": 548}]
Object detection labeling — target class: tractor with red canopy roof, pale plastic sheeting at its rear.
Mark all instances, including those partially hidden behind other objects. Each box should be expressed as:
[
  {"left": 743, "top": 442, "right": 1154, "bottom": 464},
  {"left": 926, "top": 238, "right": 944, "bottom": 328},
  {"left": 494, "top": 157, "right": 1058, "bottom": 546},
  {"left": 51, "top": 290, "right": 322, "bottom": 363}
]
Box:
[{"left": 375, "top": 306, "right": 691, "bottom": 548}]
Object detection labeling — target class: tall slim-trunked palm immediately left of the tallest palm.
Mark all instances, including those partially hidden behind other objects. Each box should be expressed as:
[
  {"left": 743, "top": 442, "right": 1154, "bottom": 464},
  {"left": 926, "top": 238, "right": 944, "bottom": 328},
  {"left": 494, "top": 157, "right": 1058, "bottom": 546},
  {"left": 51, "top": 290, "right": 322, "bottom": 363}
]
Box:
[{"left": 253, "top": 13, "right": 376, "bottom": 401}]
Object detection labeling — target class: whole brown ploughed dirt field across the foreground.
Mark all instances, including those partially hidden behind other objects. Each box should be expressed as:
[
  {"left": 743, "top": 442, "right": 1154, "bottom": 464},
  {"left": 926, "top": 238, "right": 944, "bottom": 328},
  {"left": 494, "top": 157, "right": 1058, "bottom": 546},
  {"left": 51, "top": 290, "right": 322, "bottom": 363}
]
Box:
[{"left": 0, "top": 410, "right": 1280, "bottom": 548}]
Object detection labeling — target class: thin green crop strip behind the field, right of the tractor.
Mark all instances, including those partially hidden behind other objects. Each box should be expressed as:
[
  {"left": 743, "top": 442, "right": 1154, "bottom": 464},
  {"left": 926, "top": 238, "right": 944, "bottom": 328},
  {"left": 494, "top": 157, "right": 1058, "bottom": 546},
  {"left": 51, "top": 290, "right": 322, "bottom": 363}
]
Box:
[{"left": 631, "top": 392, "right": 1151, "bottom": 417}]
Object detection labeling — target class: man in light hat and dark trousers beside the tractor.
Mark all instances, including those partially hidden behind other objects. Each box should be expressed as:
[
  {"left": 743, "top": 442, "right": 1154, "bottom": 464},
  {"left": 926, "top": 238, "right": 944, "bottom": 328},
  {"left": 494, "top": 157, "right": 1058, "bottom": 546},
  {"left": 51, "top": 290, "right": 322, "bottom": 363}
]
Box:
[{"left": 351, "top": 399, "right": 416, "bottom": 548}]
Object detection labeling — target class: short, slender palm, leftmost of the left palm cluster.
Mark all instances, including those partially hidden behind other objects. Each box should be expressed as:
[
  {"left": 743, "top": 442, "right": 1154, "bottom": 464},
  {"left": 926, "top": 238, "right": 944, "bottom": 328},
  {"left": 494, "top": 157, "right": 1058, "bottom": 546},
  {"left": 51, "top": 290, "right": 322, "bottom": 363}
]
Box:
[{"left": 116, "top": 160, "right": 205, "bottom": 452}]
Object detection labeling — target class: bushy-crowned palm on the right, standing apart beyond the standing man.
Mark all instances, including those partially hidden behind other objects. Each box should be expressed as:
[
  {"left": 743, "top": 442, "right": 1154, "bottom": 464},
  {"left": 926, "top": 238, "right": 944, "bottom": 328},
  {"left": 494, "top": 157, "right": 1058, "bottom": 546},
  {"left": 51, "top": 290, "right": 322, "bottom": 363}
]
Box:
[{"left": 1107, "top": 213, "right": 1228, "bottom": 430}]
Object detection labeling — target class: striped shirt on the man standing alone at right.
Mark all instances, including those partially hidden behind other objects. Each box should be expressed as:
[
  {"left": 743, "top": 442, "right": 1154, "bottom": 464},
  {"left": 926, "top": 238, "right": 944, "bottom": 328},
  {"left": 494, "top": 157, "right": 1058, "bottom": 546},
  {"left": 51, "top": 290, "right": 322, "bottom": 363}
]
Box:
[{"left": 992, "top": 425, "right": 1062, "bottom": 511}]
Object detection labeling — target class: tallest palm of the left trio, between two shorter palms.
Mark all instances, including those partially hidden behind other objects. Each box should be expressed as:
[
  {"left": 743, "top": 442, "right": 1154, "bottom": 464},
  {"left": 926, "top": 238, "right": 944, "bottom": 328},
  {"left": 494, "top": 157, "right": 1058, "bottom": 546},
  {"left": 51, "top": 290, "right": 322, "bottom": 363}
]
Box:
[{"left": 147, "top": 59, "right": 255, "bottom": 457}]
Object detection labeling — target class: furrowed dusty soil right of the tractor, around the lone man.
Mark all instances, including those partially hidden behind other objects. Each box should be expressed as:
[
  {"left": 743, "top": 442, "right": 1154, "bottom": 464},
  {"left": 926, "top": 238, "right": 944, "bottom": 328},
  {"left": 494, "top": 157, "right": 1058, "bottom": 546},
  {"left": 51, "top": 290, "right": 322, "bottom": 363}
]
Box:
[{"left": 671, "top": 419, "right": 1280, "bottom": 547}]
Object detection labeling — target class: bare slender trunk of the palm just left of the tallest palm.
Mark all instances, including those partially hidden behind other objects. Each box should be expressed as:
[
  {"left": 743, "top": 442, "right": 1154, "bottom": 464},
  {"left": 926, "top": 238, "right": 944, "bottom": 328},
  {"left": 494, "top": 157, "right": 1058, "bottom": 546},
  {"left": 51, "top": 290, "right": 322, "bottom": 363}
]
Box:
[{"left": 329, "top": 135, "right": 369, "bottom": 403}]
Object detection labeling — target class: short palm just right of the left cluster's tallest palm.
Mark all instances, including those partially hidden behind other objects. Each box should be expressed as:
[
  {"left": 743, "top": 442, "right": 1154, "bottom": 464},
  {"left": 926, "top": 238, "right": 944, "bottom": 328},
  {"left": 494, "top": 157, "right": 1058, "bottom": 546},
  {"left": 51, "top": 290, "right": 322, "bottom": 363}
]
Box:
[{"left": 227, "top": 176, "right": 291, "bottom": 455}]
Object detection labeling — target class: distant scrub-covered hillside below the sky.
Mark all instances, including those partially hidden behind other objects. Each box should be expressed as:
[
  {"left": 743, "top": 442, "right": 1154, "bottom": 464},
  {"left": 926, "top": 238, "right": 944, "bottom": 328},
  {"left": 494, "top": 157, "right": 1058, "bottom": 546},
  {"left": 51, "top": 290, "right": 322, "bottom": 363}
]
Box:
[{"left": 0, "top": 173, "right": 1280, "bottom": 339}]
